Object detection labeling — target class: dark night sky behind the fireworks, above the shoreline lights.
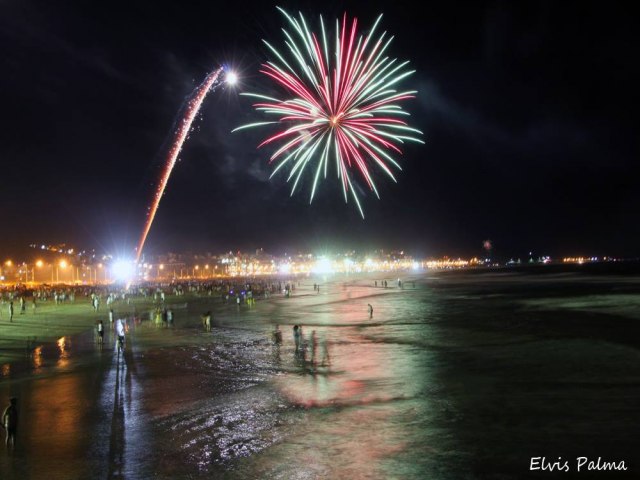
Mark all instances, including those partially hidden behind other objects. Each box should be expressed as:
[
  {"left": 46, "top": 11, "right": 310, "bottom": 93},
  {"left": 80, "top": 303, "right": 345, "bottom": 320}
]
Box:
[{"left": 0, "top": 0, "right": 640, "bottom": 262}]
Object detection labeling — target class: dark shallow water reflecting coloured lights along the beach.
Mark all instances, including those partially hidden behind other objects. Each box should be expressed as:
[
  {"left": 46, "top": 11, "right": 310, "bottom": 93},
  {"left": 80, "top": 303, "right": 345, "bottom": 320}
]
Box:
[{"left": 0, "top": 273, "right": 640, "bottom": 479}]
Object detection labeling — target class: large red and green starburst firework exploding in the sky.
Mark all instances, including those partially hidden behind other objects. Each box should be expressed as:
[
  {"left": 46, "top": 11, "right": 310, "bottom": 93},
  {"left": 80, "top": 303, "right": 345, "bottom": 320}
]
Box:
[{"left": 234, "top": 8, "right": 424, "bottom": 218}]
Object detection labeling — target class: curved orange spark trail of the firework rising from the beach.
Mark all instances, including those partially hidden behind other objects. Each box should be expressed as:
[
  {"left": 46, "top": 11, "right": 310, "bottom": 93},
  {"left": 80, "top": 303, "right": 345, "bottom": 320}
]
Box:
[{"left": 136, "top": 67, "right": 225, "bottom": 263}]
